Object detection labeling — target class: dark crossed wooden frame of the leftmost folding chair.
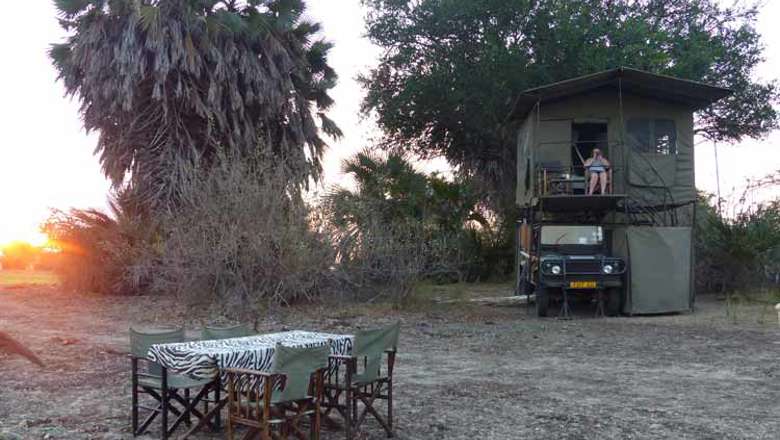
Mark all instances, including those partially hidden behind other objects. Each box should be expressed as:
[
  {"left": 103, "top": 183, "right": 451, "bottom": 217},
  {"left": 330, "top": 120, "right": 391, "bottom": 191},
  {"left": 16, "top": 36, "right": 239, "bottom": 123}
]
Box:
[{"left": 130, "top": 355, "right": 221, "bottom": 440}]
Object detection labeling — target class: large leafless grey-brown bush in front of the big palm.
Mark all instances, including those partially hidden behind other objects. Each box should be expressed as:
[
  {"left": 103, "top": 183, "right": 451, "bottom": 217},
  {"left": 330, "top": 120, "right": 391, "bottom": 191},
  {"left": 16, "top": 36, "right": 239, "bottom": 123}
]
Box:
[{"left": 155, "top": 153, "right": 334, "bottom": 317}]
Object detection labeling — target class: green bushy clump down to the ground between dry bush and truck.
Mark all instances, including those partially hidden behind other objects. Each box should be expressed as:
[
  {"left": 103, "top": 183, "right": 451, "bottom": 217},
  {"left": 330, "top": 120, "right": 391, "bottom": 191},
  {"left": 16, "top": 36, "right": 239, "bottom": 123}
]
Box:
[{"left": 323, "top": 150, "right": 511, "bottom": 293}]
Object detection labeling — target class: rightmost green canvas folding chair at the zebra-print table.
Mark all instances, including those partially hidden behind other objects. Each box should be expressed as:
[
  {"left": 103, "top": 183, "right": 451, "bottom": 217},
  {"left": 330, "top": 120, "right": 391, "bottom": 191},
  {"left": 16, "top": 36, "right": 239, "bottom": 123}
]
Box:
[{"left": 323, "top": 323, "right": 400, "bottom": 440}]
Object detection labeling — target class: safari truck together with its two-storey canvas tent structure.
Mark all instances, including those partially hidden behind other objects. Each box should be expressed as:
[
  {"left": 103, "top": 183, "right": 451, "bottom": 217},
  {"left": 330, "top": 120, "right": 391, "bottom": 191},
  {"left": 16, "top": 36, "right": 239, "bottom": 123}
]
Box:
[{"left": 510, "top": 68, "right": 730, "bottom": 316}]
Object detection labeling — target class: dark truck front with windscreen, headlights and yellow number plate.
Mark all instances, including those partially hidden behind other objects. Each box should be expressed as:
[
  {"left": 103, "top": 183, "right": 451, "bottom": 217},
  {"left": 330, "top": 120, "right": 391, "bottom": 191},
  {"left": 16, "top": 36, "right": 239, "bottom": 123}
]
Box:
[{"left": 532, "top": 225, "right": 627, "bottom": 316}]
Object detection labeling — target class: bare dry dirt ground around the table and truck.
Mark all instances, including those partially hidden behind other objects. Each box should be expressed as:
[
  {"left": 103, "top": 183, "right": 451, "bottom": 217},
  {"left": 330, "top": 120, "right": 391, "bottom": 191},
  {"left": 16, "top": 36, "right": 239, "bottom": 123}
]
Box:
[{"left": 0, "top": 286, "right": 780, "bottom": 440}]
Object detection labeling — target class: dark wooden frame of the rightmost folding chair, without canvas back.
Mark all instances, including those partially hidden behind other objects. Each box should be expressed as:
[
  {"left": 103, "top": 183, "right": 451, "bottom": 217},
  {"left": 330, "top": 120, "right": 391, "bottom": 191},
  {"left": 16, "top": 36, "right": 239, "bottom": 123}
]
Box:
[{"left": 323, "top": 350, "right": 396, "bottom": 440}]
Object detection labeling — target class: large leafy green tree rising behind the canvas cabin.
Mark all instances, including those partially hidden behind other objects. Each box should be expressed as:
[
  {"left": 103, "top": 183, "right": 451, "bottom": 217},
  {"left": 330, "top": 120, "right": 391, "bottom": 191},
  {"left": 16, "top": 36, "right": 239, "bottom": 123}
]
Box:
[{"left": 363, "top": 0, "right": 778, "bottom": 207}]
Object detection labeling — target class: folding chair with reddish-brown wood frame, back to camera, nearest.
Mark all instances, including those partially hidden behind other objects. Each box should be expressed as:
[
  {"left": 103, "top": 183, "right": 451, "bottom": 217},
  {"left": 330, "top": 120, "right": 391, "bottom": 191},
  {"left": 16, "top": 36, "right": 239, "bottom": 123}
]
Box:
[{"left": 225, "top": 344, "right": 330, "bottom": 440}]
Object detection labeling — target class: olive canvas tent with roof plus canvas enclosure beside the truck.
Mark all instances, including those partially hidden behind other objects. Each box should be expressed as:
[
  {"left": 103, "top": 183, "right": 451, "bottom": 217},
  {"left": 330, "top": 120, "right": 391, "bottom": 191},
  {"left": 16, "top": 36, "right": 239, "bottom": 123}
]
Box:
[{"left": 510, "top": 68, "right": 730, "bottom": 314}]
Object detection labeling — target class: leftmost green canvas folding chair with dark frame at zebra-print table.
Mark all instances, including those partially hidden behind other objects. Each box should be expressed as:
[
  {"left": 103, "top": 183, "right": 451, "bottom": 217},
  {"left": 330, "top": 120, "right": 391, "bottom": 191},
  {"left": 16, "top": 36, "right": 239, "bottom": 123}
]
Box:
[{"left": 130, "top": 328, "right": 219, "bottom": 439}]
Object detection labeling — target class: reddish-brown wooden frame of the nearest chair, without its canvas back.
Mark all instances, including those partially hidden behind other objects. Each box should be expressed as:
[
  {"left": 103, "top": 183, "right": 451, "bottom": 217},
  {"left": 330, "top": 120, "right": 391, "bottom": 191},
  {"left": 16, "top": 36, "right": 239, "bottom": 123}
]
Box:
[{"left": 225, "top": 368, "right": 324, "bottom": 440}]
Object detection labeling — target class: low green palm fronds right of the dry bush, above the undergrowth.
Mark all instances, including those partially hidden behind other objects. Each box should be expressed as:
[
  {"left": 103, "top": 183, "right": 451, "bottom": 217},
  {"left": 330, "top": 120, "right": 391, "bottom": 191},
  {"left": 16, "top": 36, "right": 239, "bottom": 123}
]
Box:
[{"left": 323, "top": 149, "right": 487, "bottom": 257}]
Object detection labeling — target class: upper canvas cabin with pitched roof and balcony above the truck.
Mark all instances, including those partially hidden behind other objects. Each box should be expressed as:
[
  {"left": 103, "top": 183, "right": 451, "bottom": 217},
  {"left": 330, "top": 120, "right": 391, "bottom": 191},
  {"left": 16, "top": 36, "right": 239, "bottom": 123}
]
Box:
[{"left": 511, "top": 68, "right": 730, "bottom": 220}]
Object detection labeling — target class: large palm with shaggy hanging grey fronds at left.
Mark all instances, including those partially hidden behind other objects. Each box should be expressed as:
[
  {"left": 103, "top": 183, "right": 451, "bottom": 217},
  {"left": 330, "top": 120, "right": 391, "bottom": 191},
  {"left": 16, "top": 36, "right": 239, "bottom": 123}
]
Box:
[{"left": 51, "top": 0, "right": 340, "bottom": 208}]
